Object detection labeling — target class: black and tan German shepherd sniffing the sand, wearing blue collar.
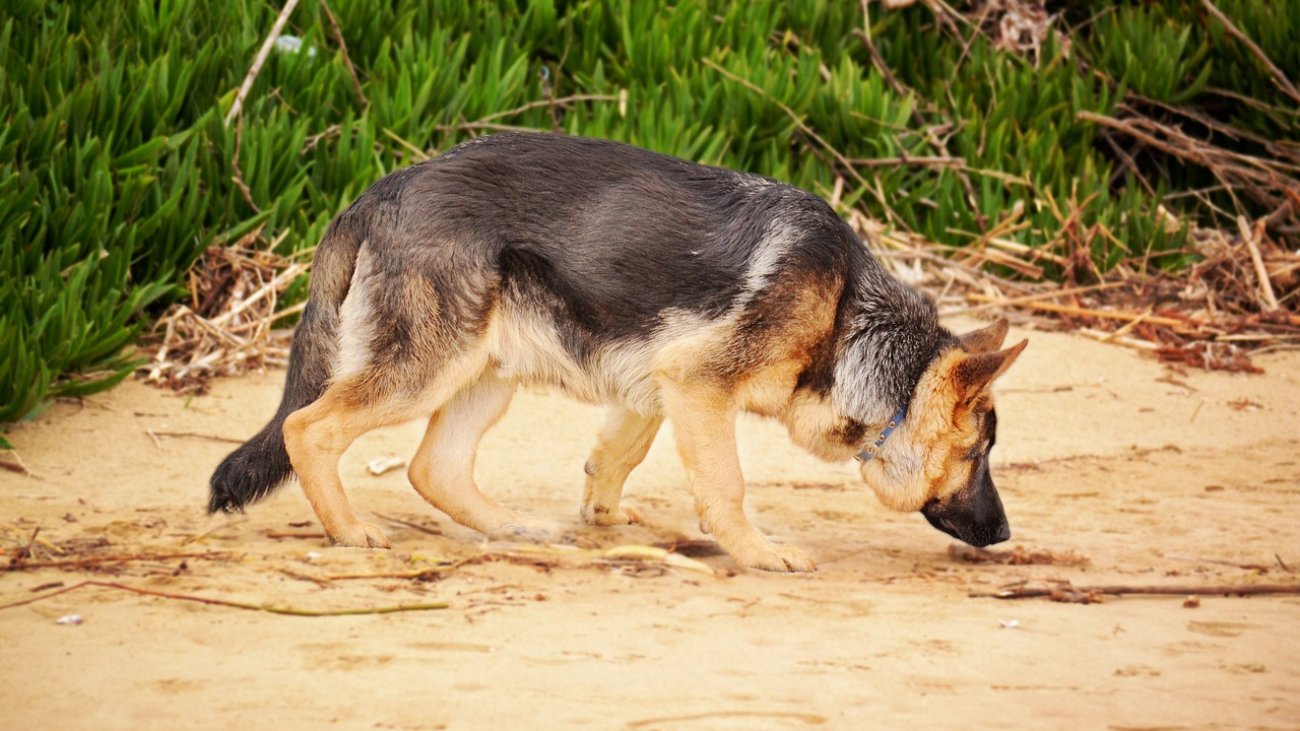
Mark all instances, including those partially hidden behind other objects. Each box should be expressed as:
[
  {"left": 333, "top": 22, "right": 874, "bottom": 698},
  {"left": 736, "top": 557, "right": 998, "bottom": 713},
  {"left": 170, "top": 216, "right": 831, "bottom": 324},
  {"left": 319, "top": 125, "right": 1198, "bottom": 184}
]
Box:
[{"left": 209, "top": 134, "right": 1027, "bottom": 571}]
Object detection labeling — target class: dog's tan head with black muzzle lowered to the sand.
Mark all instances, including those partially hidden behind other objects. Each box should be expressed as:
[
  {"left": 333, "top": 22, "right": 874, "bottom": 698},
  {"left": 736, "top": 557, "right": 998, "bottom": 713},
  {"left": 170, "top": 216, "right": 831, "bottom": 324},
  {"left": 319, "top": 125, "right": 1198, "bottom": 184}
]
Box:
[{"left": 862, "top": 320, "right": 1028, "bottom": 546}]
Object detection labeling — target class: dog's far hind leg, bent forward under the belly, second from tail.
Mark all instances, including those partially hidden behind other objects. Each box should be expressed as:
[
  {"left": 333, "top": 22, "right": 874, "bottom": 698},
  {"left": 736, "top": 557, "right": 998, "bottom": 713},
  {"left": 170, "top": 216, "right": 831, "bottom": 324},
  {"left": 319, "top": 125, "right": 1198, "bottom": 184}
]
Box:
[{"left": 407, "top": 368, "right": 553, "bottom": 538}]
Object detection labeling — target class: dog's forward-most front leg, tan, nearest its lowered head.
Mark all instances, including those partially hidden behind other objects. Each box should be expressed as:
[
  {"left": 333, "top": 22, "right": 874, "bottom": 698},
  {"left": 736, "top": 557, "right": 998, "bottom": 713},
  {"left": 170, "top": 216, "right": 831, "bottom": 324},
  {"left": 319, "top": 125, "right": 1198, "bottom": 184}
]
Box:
[{"left": 660, "top": 381, "right": 815, "bottom": 571}]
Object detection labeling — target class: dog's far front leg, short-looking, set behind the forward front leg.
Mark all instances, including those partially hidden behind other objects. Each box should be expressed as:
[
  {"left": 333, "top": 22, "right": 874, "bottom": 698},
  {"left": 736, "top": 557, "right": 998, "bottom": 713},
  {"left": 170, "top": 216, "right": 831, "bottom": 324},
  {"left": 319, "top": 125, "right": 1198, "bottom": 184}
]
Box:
[{"left": 581, "top": 406, "right": 663, "bottom": 525}]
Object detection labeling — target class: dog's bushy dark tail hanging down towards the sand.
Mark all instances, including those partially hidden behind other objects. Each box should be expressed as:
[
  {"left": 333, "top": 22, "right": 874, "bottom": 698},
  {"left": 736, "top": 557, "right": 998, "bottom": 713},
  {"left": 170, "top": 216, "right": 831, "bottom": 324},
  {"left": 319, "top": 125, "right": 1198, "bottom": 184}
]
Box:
[{"left": 208, "top": 215, "right": 365, "bottom": 512}]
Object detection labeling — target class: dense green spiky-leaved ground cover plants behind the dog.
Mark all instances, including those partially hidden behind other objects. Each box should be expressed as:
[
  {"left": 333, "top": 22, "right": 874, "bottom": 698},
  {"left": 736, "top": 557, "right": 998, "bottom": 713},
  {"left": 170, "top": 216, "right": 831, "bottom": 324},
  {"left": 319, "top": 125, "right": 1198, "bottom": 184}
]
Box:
[{"left": 0, "top": 0, "right": 1300, "bottom": 423}]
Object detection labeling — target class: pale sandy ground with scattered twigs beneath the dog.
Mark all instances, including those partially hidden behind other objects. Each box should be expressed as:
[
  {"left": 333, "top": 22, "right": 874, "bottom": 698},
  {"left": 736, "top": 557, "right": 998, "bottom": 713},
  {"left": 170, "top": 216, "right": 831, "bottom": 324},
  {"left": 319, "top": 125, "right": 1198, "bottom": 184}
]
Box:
[{"left": 0, "top": 319, "right": 1300, "bottom": 730}]
